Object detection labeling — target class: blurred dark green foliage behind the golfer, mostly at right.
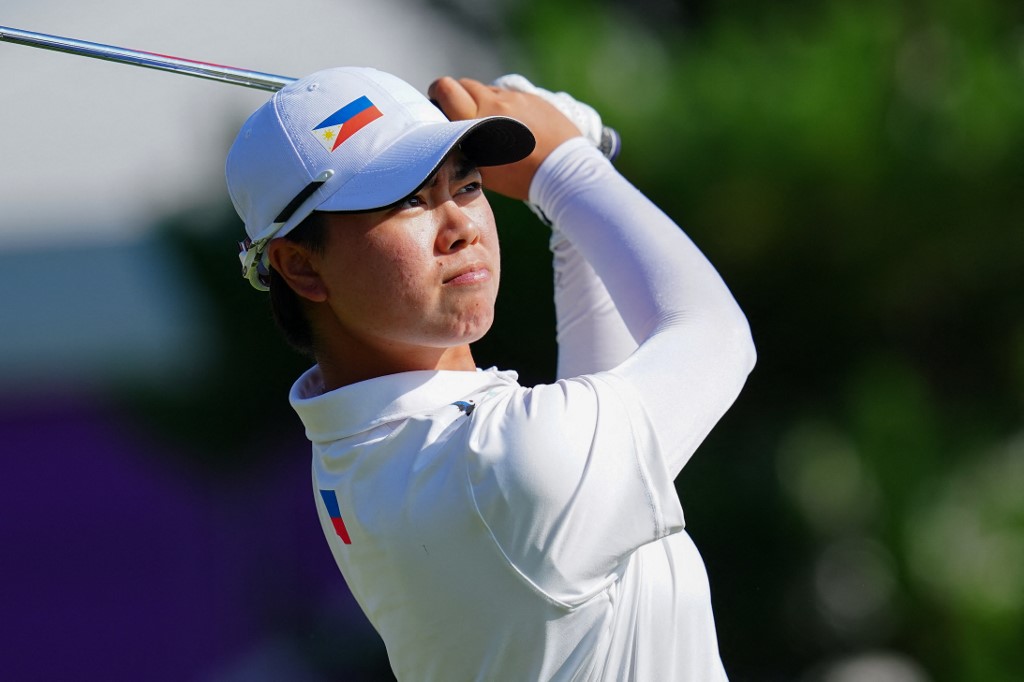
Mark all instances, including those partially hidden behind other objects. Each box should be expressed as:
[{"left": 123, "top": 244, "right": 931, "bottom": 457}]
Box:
[{"left": 132, "top": 0, "right": 1024, "bottom": 682}]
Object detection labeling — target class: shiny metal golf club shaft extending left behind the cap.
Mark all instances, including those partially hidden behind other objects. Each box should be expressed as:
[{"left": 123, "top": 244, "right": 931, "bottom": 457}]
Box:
[{"left": 0, "top": 26, "right": 295, "bottom": 92}]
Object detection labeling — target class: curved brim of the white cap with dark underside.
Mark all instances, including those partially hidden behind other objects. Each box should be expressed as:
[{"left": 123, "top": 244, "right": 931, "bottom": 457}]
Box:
[{"left": 307, "top": 117, "right": 536, "bottom": 213}]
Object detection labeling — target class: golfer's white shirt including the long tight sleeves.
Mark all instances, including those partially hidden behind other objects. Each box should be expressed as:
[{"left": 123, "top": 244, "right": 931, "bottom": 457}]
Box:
[{"left": 291, "top": 139, "right": 754, "bottom": 682}]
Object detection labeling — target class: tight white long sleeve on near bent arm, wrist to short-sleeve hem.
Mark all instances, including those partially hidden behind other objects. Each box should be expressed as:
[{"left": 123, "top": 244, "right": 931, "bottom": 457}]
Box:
[{"left": 530, "top": 140, "right": 755, "bottom": 472}]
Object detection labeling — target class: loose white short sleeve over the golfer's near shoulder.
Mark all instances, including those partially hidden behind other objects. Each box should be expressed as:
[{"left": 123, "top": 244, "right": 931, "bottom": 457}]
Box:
[{"left": 467, "top": 373, "right": 683, "bottom": 607}]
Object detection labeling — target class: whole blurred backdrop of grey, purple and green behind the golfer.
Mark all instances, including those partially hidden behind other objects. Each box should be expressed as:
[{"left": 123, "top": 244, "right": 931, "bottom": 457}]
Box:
[{"left": 0, "top": 0, "right": 1024, "bottom": 682}]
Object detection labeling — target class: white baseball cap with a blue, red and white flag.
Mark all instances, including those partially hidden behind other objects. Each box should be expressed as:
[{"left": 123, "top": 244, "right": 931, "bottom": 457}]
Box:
[{"left": 226, "top": 67, "right": 535, "bottom": 291}]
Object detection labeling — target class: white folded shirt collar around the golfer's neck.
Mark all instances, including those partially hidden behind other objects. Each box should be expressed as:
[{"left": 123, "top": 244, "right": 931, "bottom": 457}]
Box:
[{"left": 289, "top": 366, "right": 518, "bottom": 442}]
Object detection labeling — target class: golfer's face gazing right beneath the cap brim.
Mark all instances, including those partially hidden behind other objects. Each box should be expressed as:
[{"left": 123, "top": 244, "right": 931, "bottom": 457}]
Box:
[{"left": 314, "top": 154, "right": 500, "bottom": 353}]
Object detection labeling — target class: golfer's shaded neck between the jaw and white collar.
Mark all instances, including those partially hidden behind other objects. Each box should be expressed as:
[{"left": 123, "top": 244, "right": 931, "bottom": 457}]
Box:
[{"left": 316, "top": 337, "right": 476, "bottom": 391}]
